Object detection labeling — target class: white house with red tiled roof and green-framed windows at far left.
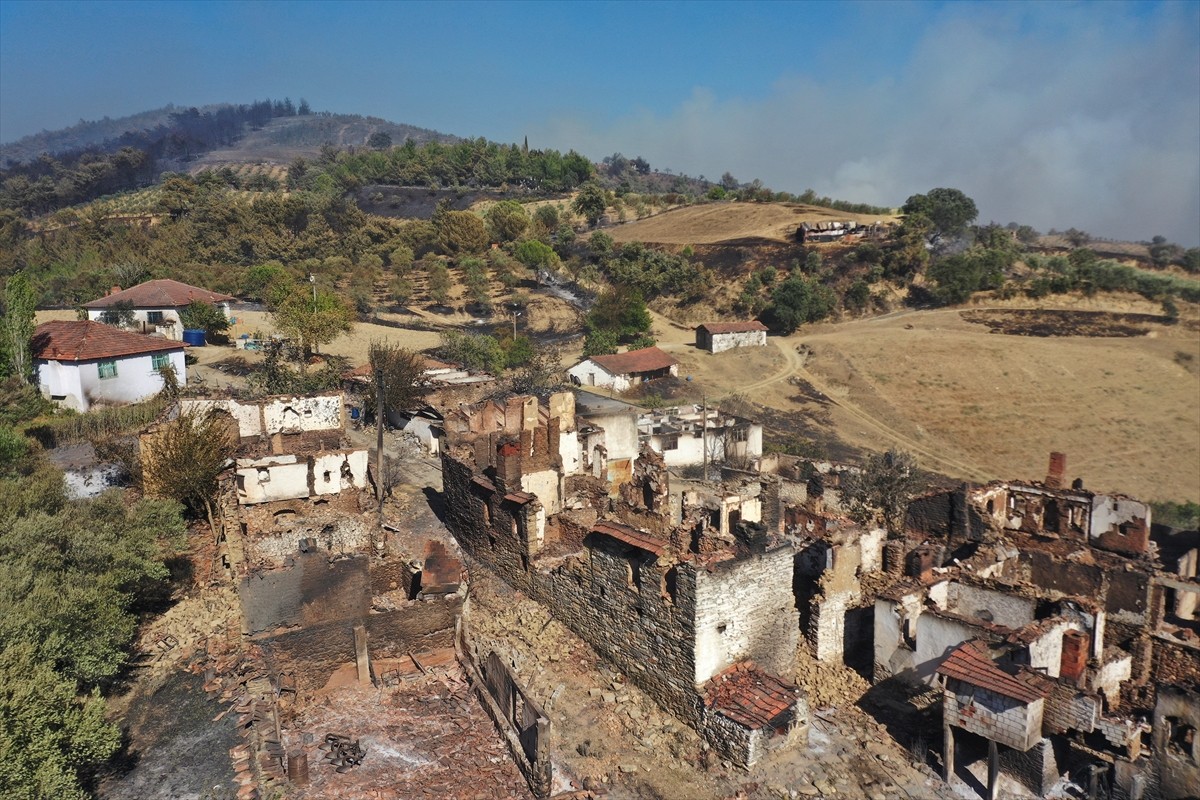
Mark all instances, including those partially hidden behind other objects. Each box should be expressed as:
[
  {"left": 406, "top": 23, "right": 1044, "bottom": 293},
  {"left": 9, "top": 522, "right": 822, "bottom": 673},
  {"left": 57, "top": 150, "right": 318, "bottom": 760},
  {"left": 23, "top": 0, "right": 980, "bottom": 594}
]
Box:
[{"left": 30, "top": 320, "right": 187, "bottom": 411}]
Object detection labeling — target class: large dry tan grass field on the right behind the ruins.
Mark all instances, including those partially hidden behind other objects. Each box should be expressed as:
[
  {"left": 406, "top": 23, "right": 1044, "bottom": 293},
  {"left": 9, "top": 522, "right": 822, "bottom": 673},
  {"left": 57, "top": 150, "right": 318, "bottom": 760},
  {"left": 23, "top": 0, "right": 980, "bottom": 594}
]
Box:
[{"left": 655, "top": 299, "right": 1200, "bottom": 500}]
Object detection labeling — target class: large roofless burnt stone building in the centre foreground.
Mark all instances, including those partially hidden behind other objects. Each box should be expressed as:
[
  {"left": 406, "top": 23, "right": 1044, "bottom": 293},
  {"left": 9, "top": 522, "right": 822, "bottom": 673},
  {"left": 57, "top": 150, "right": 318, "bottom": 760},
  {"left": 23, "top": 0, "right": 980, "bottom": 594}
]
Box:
[{"left": 442, "top": 392, "right": 806, "bottom": 764}]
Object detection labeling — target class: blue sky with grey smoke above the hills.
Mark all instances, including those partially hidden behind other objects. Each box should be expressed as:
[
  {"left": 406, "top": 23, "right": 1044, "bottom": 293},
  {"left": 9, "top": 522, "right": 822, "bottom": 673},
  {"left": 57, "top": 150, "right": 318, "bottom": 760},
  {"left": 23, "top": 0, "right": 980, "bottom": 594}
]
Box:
[{"left": 0, "top": 0, "right": 1200, "bottom": 245}]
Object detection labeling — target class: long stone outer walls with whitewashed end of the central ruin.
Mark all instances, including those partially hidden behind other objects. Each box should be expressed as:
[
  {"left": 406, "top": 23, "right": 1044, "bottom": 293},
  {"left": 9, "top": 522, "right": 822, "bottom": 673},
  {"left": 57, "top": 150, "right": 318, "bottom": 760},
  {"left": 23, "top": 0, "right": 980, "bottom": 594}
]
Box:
[{"left": 443, "top": 452, "right": 798, "bottom": 724}]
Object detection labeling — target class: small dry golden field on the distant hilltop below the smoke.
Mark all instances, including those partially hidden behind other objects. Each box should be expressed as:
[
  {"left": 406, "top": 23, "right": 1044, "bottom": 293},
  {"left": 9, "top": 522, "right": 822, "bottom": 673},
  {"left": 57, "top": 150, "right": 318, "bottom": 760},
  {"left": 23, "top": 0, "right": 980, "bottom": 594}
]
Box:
[{"left": 606, "top": 203, "right": 898, "bottom": 245}]
